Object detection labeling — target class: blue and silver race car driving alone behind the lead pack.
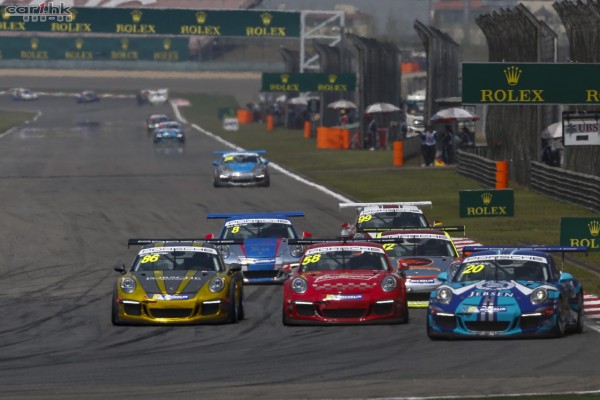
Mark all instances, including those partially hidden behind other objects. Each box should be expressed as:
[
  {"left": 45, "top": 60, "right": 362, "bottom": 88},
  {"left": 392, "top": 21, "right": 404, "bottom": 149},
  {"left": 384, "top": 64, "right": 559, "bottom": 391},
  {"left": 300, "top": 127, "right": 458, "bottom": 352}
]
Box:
[{"left": 213, "top": 150, "right": 270, "bottom": 187}]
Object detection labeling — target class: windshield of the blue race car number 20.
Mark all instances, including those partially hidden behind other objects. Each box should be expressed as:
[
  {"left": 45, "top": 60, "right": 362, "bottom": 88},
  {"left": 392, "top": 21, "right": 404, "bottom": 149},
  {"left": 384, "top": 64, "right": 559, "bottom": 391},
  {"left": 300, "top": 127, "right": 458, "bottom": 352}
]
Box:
[{"left": 452, "top": 259, "right": 550, "bottom": 282}]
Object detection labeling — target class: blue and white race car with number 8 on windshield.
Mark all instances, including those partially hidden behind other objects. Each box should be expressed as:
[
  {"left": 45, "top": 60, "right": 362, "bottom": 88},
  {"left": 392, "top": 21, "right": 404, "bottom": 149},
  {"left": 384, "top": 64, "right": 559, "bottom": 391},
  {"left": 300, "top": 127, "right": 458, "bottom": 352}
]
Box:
[{"left": 206, "top": 212, "right": 311, "bottom": 283}]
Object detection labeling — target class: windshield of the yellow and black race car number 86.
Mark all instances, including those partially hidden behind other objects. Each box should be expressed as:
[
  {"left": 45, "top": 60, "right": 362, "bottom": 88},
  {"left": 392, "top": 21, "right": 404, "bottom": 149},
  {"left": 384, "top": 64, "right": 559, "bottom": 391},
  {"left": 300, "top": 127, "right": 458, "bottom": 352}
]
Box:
[{"left": 131, "top": 251, "right": 224, "bottom": 272}]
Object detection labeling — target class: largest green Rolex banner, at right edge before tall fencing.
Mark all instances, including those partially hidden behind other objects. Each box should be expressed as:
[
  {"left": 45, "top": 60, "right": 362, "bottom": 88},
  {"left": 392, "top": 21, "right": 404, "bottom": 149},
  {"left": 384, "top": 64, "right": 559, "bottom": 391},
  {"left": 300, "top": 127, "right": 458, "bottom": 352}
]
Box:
[{"left": 462, "top": 63, "right": 600, "bottom": 105}]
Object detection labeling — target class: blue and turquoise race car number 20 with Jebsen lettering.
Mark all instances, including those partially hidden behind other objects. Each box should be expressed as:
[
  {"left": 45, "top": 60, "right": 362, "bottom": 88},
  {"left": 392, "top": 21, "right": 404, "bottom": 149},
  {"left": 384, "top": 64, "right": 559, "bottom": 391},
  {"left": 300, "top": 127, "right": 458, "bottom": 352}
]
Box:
[{"left": 427, "top": 246, "right": 587, "bottom": 339}]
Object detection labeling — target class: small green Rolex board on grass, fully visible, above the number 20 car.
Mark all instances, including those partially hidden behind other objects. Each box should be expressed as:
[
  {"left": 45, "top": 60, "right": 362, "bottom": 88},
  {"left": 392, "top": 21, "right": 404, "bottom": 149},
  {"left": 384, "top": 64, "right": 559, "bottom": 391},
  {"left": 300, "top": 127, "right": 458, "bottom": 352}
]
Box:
[{"left": 458, "top": 189, "right": 515, "bottom": 218}]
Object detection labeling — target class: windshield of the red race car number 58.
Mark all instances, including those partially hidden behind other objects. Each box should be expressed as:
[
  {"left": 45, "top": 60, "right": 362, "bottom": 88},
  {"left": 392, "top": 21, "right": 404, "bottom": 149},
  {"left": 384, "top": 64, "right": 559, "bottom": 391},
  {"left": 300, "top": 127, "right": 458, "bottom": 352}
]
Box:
[{"left": 301, "top": 250, "right": 388, "bottom": 272}]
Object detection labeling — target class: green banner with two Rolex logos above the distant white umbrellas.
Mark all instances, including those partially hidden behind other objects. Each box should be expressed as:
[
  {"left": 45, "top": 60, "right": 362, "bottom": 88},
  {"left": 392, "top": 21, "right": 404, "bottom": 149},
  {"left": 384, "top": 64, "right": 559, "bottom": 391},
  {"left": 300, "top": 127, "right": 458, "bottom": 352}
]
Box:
[{"left": 261, "top": 72, "right": 356, "bottom": 92}]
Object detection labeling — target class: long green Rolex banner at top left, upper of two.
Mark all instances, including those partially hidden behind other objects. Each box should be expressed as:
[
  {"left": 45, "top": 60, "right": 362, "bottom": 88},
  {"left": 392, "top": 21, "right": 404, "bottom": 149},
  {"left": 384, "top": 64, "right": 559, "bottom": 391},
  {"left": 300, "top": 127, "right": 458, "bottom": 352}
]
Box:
[{"left": 0, "top": 6, "right": 300, "bottom": 37}]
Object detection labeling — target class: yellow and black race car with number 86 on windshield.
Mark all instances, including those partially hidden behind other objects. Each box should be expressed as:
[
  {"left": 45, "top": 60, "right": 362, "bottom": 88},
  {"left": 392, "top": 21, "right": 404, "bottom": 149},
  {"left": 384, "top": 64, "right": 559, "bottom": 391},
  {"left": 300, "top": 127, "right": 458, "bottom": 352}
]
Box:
[{"left": 112, "top": 239, "right": 244, "bottom": 325}]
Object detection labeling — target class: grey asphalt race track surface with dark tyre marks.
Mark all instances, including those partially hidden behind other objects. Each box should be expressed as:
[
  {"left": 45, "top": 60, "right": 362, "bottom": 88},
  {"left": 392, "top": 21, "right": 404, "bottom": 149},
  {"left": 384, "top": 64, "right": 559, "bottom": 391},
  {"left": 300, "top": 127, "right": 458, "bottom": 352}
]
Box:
[{"left": 0, "top": 78, "right": 600, "bottom": 400}]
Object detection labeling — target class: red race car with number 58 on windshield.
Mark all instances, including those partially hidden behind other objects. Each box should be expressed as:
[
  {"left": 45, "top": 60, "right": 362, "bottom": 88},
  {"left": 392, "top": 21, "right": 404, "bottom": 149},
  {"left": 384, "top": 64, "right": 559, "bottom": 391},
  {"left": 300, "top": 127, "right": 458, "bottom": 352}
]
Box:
[{"left": 283, "top": 238, "right": 408, "bottom": 325}]
